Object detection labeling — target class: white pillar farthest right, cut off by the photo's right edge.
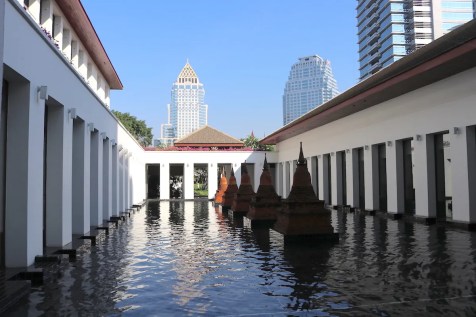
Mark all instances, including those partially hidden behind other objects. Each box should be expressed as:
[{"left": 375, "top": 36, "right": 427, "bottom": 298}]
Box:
[{"left": 450, "top": 126, "right": 476, "bottom": 223}]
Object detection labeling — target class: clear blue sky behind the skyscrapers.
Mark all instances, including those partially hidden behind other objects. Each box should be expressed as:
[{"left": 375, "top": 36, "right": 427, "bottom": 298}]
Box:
[{"left": 82, "top": 0, "right": 359, "bottom": 138}]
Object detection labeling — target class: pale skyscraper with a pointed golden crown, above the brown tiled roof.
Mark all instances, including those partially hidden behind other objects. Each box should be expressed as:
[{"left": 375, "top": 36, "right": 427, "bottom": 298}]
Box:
[{"left": 161, "top": 61, "right": 208, "bottom": 145}]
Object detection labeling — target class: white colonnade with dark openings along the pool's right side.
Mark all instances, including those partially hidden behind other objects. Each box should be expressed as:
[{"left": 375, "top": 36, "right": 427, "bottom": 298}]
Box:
[{"left": 276, "top": 125, "right": 476, "bottom": 224}]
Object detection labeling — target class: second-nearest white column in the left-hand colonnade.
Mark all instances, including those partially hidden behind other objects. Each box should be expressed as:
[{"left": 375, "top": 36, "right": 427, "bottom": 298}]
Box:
[{"left": 46, "top": 106, "right": 73, "bottom": 247}]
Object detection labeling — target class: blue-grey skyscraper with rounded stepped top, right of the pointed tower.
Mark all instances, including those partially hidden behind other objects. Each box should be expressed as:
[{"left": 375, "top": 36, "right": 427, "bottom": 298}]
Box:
[{"left": 283, "top": 55, "right": 339, "bottom": 125}]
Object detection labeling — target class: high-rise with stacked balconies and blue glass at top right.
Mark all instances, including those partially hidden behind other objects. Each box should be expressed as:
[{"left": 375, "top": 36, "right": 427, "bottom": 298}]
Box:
[{"left": 357, "top": 0, "right": 476, "bottom": 80}]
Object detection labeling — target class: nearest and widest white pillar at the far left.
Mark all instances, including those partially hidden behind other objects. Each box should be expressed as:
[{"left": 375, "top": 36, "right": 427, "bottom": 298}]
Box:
[{"left": 4, "top": 80, "right": 45, "bottom": 267}]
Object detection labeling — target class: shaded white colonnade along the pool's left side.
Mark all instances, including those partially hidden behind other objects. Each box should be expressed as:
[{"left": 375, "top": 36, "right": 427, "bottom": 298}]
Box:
[{"left": 0, "top": 75, "right": 133, "bottom": 267}]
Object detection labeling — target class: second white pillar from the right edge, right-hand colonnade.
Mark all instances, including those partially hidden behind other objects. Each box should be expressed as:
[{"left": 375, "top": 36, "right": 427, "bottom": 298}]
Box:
[{"left": 412, "top": 134, "right": 436, "bottom": 218}]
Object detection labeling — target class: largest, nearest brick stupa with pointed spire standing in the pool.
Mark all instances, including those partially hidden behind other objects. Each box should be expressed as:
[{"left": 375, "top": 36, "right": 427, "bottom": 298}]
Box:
[{"left": 273, "top": 142, "right": 339, "bottom": 243}]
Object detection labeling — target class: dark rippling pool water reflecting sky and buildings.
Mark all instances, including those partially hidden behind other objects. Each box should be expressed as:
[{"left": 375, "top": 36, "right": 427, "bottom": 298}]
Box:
[{"left": 8, "top": 201, "right": 476, "bottom": 316}]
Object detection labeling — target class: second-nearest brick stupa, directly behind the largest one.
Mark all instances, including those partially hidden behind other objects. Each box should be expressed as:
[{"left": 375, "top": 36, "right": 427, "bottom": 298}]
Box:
[{"left": 246, "top": 154, "right": 281, "bottom": 228}]
